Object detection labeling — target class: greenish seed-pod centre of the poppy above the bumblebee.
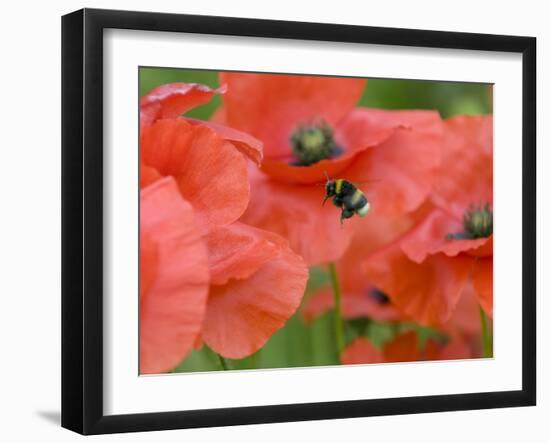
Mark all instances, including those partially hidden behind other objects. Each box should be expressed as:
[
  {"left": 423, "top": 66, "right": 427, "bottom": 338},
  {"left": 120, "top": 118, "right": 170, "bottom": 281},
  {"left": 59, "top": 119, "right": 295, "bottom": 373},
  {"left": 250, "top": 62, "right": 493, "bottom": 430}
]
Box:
[{"left": 290, "top": 120, "right": 342, "bottom": 166}]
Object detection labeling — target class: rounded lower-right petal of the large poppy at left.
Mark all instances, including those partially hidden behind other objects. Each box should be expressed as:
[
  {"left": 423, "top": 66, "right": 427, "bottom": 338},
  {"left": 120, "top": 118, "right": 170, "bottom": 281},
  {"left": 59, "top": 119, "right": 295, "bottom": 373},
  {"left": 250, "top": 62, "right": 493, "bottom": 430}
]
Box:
[{"left": 202, "top": 225, "right": 308, "bottom": 358}]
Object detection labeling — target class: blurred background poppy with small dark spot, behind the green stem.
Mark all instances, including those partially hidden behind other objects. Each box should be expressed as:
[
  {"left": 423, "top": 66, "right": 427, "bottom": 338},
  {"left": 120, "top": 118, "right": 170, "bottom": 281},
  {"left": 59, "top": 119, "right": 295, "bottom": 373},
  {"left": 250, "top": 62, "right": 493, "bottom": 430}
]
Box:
[{"left": 302, "top": 214, "right": 412, "bottom": 321}]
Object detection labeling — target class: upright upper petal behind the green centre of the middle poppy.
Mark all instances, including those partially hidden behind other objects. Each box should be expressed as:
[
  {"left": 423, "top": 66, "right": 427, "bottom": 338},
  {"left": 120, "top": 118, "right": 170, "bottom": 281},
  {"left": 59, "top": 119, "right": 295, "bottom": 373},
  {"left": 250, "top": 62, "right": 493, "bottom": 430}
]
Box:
[{"left": 220, "top": 72, "right": 366, "bottom": 158}]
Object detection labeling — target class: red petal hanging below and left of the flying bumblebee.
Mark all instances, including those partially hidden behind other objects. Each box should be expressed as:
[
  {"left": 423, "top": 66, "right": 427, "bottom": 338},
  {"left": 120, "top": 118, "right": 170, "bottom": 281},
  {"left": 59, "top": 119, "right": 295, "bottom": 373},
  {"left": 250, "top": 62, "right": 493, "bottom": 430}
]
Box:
[{"left": 242, "top": 170, "right": 352, "bottom": 265}]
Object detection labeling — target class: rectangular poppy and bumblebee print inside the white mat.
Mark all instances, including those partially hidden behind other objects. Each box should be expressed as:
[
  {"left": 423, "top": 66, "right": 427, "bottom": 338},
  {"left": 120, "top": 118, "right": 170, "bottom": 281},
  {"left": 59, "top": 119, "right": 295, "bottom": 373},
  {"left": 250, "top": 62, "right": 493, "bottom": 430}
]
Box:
[{"left": 139, "top": 67, "right": 493, "bottom": 375}]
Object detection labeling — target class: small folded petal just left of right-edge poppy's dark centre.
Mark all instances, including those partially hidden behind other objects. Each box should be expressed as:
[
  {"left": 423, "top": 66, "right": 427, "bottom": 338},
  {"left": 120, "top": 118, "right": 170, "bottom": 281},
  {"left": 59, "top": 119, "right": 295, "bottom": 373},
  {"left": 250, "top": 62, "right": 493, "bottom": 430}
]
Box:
[{"left": 401, "top": 209, "right": 496, "bottom": 263}]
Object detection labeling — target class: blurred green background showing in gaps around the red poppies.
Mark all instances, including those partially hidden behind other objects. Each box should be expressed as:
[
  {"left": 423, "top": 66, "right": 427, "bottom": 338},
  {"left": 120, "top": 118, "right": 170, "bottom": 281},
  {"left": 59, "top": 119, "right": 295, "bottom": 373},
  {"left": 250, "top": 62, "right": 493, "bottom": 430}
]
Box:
[{"left": 139, "top": 68, "right": 492, "bottom": 372}]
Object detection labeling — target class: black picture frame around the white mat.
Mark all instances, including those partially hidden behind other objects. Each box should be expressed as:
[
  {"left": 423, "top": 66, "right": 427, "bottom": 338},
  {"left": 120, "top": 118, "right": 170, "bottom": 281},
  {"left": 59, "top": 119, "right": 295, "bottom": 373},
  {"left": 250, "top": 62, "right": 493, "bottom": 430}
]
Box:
[{"left": 62, "top": 9, "right": 536, "bottom": 434}]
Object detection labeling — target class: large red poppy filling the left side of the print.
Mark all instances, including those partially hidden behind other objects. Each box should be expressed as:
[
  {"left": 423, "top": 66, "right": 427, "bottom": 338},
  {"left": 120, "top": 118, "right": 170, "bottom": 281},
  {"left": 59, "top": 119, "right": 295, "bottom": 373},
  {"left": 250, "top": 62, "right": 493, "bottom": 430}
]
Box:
[{"left": 140, "top": 85, "right": 308, "bottom": 373}]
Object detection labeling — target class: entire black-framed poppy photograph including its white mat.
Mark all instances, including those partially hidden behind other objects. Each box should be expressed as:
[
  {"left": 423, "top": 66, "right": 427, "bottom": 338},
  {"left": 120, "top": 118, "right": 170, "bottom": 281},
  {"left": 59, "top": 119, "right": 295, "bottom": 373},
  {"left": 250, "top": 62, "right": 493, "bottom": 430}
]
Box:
[{"left": 62, "top": 9, "right": 536, "bottom": 434}]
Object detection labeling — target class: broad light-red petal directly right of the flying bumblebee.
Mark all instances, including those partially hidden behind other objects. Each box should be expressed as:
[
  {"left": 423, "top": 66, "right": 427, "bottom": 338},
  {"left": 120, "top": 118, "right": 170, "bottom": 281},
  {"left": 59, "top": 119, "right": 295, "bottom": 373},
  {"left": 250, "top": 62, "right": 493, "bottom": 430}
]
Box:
[{"left": 345, "top": 111, "right": 442, "bottom": 215}]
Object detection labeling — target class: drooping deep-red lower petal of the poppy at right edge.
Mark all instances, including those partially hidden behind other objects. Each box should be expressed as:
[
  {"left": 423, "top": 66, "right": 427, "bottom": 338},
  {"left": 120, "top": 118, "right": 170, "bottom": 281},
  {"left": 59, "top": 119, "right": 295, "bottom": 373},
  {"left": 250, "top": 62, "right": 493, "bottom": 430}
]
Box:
[{"left": 364, "top": 242, "right": 475, "bottom": 326}]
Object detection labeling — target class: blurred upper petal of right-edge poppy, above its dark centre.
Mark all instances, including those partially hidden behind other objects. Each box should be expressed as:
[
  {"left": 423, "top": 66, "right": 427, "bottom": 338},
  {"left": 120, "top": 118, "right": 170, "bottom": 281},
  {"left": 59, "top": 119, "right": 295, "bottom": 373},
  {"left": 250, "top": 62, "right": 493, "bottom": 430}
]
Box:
[{"left": 433, "top": 116, "right": 493, "bottom": 218}]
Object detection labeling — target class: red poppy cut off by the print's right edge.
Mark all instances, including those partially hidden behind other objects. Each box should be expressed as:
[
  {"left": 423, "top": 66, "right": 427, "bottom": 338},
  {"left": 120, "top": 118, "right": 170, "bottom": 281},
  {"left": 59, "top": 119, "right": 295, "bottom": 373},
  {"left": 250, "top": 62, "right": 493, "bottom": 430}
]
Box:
[{"left": 365, "top": 117, "right": 493, "bottom": 326}]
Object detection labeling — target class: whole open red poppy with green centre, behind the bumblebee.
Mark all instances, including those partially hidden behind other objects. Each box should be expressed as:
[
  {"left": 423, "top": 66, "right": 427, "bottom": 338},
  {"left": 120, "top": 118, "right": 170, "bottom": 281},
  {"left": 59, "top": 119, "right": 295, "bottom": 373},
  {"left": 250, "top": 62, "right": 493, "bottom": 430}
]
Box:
[{"left": 216, "top": 73, "right": 441, "bottom": 264}]
